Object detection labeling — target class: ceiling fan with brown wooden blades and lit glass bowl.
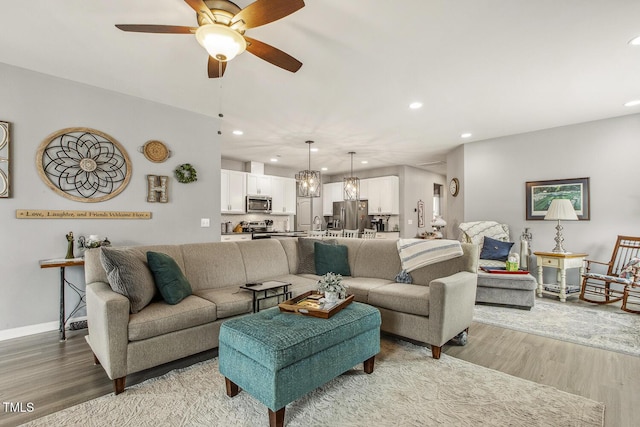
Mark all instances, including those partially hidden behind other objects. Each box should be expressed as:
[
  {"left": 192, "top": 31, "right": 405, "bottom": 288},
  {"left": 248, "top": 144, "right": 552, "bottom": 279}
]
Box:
[{"left": 116, "top": 0, "right": 304, "bottom": 78}]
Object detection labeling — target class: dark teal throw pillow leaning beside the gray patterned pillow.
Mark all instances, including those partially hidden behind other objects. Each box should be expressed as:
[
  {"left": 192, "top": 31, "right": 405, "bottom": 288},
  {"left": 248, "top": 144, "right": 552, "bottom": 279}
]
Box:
[{"left": 147, "top": 251, "right": 192, "bottom": 305}]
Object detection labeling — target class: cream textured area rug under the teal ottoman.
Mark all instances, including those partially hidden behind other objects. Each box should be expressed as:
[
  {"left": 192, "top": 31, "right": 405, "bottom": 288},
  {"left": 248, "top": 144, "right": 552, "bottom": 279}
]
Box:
[{"left": 26, "top": 338, "right": 604, "bottom": 427}]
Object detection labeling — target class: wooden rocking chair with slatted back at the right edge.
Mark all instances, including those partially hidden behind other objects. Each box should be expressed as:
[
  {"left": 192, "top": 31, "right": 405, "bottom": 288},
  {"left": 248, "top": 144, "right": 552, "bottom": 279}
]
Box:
[{"left": 580, "top": 236, "right": 640, "bottom": 313}]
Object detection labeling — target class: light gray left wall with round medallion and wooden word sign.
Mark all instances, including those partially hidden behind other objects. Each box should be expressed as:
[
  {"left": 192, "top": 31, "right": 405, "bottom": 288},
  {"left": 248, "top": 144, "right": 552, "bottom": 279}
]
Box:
[{"left": 0, "top": 64, "right": 220, "bottom": 338}]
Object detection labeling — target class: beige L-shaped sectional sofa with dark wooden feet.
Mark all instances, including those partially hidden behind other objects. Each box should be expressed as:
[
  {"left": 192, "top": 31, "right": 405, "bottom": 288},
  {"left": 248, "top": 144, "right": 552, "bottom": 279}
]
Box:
[{"left": 85, "top": 238, "right": 478, "bottom": 394}]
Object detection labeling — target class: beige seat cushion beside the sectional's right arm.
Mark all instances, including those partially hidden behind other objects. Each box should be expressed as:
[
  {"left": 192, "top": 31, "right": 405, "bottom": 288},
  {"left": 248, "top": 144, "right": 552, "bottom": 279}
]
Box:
[{"left": 369, "top": 283, "right": 429, "bottom": 316}]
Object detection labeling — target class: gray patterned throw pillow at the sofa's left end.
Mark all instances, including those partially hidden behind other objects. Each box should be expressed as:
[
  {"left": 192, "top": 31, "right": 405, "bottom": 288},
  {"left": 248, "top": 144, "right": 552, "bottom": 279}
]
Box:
[{"left": 100, "top": 247, "right": 156, "bottom": 314}]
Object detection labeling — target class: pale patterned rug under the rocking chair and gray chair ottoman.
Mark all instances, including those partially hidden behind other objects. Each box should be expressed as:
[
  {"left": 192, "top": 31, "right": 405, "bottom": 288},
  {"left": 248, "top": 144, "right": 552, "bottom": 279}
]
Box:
[{"left": 473, "top": 298, "right": 640, "bottom": 356}]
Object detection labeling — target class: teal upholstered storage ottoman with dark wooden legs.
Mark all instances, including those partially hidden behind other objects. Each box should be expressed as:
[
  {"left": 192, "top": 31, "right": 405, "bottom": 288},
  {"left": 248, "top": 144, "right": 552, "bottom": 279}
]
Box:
[{"left": 218, "top": 302, "right": 380, "bottom": 426}]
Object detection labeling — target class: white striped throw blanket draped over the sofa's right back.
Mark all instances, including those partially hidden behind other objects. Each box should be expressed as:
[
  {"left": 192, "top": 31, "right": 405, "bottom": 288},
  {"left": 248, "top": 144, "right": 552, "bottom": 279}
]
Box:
[{"left": 397, "top": 239, "right": 462, "bottom": 273}]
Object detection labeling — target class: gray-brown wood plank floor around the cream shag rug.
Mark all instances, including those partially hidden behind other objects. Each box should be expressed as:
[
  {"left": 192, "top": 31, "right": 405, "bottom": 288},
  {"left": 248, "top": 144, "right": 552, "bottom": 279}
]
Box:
[{"left": 0, "top": 323, "right": 640, "bottom": 427}]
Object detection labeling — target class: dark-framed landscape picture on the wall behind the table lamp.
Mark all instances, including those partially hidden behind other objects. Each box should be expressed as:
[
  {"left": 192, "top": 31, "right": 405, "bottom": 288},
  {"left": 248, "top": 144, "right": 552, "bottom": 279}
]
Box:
[{"left": 526, "top": 178, "right": 589, "bottom": 221}]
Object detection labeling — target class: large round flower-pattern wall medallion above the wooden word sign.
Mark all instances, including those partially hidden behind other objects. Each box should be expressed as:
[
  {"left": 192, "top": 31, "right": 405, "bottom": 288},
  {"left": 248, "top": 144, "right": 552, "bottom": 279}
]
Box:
[{"left": 36, "top": 128, "right": 131, "bottom": 202}]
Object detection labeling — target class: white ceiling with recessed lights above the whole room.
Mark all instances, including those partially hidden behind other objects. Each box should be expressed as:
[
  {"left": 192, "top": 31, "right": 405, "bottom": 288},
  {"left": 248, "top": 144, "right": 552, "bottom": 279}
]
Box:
[{"left": 0, "top": 0, "right": 640, "bottom": 174}]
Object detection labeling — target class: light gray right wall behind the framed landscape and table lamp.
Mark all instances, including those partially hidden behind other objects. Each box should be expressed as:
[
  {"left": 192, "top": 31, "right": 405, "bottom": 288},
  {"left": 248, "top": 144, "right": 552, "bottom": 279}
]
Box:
[{"left": 447, "top": 114, "right": 640, "bottom": 284}]
